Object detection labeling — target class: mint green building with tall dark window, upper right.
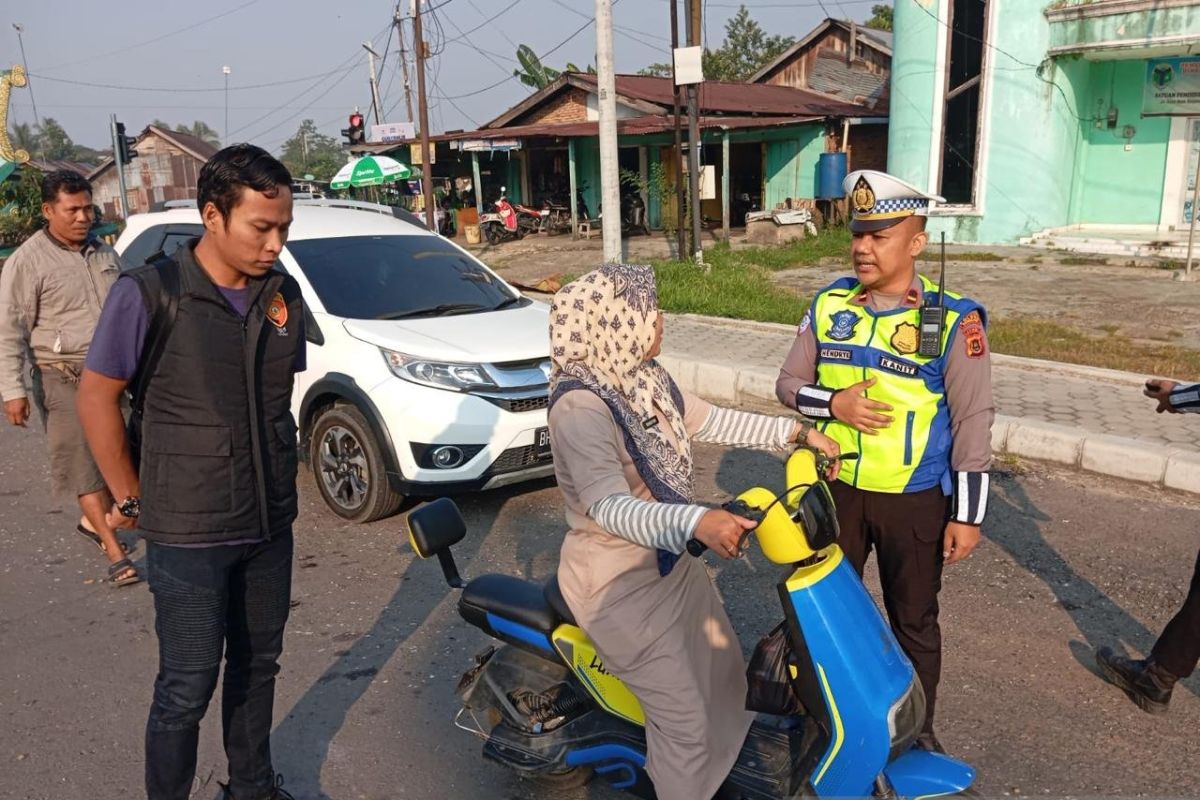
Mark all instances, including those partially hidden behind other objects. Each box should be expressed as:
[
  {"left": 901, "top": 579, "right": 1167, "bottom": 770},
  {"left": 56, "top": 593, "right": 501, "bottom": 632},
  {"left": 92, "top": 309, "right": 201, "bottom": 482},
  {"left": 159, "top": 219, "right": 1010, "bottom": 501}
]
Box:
[{"left": 888, "top": 0, "right": 1200, "bottom": 250}]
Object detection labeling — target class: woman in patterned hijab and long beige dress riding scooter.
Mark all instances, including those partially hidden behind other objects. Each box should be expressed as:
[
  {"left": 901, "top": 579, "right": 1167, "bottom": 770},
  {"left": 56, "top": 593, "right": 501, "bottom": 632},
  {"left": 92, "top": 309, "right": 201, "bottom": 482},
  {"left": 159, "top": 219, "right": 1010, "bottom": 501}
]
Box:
[{"left": 550, "top": 264, "right": 838, "bottom": 800}]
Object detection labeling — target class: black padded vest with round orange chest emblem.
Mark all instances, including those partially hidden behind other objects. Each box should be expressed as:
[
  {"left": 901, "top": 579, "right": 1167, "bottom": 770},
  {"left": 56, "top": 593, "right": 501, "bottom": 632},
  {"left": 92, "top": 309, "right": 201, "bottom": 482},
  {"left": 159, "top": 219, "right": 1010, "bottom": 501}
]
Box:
[{"left": 130, "top": 241, "right": 304, "bottom": 545}]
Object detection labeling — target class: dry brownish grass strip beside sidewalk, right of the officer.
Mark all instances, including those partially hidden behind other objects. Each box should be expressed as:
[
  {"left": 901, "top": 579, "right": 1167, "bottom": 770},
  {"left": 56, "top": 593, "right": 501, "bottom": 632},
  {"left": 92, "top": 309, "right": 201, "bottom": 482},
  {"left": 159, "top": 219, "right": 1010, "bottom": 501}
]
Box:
[{"left": 988, "top": 318, "right": 1200, "bottom": 375}]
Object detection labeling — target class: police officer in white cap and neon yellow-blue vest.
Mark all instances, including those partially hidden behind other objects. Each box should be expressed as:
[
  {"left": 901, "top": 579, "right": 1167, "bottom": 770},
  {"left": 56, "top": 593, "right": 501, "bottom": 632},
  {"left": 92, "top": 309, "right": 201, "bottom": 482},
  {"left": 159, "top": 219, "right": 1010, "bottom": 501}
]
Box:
[{"left": 775, "top": 170, "right": 995, "bottom": 752}]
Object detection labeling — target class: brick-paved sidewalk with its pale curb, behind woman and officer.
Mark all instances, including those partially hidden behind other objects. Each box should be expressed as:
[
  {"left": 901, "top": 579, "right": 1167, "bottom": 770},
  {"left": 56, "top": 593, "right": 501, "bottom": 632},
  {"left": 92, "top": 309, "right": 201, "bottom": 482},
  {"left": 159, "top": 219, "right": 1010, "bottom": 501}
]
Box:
[{"left": 662, "top": 315, "right": 1200, "bottom": 492}]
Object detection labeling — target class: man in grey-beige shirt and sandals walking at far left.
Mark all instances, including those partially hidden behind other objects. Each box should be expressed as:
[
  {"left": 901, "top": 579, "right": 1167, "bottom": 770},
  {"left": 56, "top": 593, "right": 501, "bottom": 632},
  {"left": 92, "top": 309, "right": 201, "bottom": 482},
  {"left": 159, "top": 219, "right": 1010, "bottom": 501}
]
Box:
[{"left": 0, "top": 170, "right": 138, "bottom": 585}]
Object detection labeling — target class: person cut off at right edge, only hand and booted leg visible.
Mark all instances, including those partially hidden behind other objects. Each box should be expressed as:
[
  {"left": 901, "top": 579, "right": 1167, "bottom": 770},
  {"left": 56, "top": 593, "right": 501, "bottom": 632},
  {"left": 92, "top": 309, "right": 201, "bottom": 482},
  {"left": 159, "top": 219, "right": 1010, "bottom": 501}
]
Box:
[{"left": 1096, "top": 379, "right": 1200, "bottom": 714}]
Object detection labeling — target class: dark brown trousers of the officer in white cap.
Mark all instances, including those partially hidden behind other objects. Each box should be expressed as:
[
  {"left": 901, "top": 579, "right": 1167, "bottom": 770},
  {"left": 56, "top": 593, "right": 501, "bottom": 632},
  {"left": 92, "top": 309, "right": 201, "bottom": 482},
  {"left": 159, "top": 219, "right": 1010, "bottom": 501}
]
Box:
[{"left": 830, "top": 481, "right": 950, "bottom": 732}]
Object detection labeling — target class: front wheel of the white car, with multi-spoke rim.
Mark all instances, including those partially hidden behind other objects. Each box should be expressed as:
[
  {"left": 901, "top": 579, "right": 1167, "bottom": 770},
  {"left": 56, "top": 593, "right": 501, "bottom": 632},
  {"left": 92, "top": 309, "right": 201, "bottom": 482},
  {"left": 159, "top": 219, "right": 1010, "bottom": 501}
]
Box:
[{"left": 308, "top": 403, "right": 404, "bottom": 523}]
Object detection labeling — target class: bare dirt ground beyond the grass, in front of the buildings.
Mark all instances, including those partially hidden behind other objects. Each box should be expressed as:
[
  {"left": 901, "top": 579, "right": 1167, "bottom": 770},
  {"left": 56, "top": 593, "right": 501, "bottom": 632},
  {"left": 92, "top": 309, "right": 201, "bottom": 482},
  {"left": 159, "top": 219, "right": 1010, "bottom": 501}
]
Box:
[{"left": 470, "top": 234, "right": 1200, "bottom": 349}]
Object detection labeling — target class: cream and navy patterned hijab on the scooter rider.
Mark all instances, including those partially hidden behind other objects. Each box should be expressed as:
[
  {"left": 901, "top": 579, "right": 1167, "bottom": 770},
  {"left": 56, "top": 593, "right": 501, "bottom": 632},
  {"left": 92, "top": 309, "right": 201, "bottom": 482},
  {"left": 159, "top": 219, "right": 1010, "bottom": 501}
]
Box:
[{"left": 550, "top": 264, "right": 692, "bottom": 503}]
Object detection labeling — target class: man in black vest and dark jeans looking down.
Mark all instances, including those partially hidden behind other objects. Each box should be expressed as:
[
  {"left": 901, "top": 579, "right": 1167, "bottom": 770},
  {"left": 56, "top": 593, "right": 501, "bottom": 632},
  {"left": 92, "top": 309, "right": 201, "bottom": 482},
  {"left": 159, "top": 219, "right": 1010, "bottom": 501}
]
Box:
[{"left": 78, "top": 144, "right": 305, "bottom": 800}]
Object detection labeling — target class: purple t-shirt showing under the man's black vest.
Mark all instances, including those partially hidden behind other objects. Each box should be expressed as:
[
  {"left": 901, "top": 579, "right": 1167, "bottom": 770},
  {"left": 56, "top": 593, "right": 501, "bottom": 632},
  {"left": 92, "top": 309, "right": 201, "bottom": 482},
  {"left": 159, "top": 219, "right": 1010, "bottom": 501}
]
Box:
[{"left": 84, "top": 276, "right": 307, "bottom": 548}]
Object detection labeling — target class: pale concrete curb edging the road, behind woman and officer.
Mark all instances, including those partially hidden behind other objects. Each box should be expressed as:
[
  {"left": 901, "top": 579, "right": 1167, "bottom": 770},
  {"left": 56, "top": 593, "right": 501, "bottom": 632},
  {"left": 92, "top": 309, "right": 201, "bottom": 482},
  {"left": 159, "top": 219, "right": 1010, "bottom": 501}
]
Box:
[{"left": 659, "top": 352, "right": 1200, "bottom": 494}]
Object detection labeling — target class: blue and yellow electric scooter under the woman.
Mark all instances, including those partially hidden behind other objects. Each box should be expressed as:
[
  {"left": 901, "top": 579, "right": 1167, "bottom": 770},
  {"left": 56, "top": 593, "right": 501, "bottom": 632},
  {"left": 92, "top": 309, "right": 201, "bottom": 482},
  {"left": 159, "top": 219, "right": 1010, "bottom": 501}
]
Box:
[{"left": 408, "top": 449, "right": 974, "bottom": 800}]
